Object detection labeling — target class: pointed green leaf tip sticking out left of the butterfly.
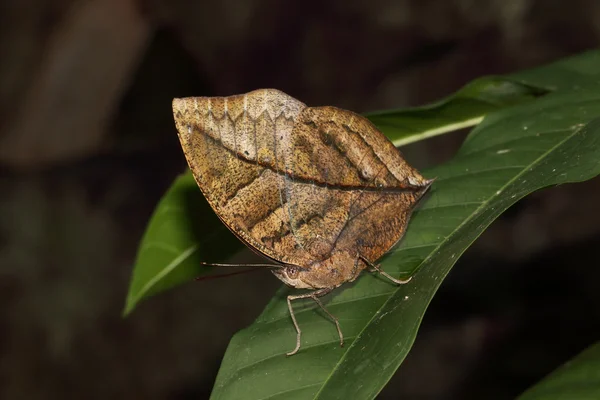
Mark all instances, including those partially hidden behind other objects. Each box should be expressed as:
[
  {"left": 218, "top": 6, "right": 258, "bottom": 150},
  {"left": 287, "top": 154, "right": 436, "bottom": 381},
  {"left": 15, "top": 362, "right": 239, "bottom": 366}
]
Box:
[{"left": 124, "top": 173, "right": 242, "bottom": 315}]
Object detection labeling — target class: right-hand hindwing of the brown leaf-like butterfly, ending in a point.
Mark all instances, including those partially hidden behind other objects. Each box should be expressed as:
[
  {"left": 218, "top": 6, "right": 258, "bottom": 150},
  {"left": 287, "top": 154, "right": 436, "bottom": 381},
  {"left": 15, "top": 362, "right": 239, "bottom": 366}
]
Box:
[{"left": 285, "top": 107, "right": 430, "bottom": 262}]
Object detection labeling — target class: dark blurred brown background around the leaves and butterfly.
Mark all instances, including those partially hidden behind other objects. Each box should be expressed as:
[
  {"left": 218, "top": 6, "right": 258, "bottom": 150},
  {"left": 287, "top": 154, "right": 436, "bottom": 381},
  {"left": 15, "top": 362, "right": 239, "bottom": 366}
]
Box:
[{"left": 0, "top": 0, "right": 600, "bottom": 399}]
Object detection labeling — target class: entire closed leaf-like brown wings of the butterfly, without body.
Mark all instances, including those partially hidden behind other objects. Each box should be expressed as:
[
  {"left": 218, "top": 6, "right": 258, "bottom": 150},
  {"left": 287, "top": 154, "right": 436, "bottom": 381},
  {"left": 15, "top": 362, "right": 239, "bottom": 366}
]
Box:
[{"left": 173, "top": 89, "right": 430, "bottom": 267}]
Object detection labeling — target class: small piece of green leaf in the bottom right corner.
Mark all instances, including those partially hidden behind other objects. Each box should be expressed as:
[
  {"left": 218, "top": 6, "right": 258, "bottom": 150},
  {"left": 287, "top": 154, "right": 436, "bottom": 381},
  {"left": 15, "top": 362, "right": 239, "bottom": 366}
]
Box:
[{"left": 519, "top": 342, "right": 600, "bottom": 400}]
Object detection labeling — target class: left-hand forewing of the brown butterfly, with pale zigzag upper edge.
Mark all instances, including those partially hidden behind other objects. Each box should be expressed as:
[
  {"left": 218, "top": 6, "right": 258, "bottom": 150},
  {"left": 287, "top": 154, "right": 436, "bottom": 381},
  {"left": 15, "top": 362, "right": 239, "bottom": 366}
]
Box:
[{"left": 173, "top": 89, "right": 308, "bottom": 264}]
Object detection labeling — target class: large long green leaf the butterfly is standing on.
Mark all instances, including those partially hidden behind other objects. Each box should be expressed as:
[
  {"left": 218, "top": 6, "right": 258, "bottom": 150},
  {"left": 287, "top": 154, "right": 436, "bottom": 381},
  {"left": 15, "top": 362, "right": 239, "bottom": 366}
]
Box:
[{"left": 213, "top": 91, "right": 600, "bottom": 399}]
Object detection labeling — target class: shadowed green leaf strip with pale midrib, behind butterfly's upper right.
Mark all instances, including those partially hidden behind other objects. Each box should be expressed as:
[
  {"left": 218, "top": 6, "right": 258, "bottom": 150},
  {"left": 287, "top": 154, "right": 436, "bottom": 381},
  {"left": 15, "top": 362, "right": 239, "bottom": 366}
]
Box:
[{"left": 366, "top": 50, "right": 600, "bottom": 147}]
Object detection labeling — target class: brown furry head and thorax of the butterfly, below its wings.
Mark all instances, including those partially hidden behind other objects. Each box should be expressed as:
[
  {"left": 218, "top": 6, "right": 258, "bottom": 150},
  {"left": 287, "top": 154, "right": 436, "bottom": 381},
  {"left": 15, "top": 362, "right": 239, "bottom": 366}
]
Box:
[{"left": 273, "top": 252, "right": 366, "bottom": 289}]
